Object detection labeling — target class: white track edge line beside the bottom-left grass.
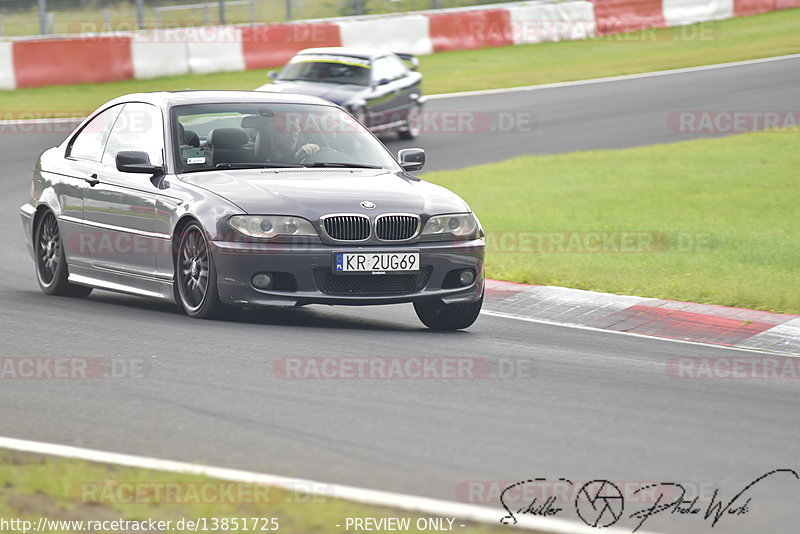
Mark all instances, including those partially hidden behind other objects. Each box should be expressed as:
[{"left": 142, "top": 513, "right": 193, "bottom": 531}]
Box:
[{"left": 0, "top": 437, "right": 664, "bottom": 534}]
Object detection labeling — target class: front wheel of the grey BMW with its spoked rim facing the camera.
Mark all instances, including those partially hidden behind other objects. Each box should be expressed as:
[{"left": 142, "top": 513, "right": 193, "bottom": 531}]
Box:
[{"left": 175, "top": 223, "right": 222, "bottom": 319}]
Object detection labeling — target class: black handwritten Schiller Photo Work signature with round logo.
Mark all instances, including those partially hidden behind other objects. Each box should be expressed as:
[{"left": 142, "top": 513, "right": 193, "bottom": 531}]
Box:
[{"left": 500, "top": 469, "right": 800, "bottom": 532}]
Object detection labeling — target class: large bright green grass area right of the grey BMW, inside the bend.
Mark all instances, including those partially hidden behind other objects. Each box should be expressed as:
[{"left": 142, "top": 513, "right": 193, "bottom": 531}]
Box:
[{"left": 424, "top": 129, "right": 800, "bottom": 313}]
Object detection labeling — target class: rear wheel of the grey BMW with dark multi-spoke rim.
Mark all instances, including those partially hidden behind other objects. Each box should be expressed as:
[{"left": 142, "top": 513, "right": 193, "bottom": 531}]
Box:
[{"left": 33, "top": 210, "right": 92, "bottom": 297}]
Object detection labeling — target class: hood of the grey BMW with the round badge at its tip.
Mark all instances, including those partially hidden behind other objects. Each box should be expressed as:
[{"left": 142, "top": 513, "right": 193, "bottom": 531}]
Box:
[{"left": 180, "top": 168, "right": 469, "bottom": 221}]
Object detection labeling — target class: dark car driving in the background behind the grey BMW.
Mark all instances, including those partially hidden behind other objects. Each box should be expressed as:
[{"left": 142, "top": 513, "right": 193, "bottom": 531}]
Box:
[{"left": 257, "top": 47, "right": 425, "bottom": 139}]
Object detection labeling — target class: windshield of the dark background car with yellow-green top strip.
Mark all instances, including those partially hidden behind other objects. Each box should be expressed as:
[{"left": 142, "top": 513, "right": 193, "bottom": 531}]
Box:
[{"left": 278, "top": 54, "right": 369, "bottom": 85}]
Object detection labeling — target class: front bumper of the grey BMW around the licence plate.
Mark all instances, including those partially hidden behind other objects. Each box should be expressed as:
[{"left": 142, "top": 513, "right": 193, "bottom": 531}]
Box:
[{"left": 211, "top": 239, "right": 485, "bottom": 307}]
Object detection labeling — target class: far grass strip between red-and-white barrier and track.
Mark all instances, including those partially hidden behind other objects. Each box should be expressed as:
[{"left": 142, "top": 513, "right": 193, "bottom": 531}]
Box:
[{"left": 0, "top": 9, "right": 800, "bottom": 119}]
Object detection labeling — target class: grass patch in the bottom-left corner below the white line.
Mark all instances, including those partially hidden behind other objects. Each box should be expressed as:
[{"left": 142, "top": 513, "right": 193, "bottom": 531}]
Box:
[{"left": 0, "top": 451, "right": 508, "bottom": 534}]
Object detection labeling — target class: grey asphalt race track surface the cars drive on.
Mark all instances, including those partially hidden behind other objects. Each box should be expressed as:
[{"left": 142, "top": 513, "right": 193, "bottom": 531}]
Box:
[{"left": 0, "top": 56, "right": 800, "bottom": 534}]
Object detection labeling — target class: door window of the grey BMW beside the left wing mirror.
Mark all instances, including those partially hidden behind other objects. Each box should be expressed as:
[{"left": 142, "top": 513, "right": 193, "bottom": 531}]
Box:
[{"left": 103, "top": 102, "right": 164, "bottom": 165}]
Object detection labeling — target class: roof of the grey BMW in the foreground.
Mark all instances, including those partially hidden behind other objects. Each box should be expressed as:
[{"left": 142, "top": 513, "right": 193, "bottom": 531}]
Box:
[{"left": 97, "top": 90, "right": 332, "bottom": 109}]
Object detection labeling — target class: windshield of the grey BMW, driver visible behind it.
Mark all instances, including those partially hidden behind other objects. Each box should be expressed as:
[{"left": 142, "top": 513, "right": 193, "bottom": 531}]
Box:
[{"left": 172, "top": 103, "right": 399, "bottom": 173}]
